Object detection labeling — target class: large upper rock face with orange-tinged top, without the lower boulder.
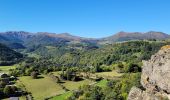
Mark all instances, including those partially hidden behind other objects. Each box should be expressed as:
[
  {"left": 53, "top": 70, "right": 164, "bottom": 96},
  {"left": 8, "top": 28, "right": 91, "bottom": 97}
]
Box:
[{"left": 141, "top": 48, "right": 170, "bottom": 93}]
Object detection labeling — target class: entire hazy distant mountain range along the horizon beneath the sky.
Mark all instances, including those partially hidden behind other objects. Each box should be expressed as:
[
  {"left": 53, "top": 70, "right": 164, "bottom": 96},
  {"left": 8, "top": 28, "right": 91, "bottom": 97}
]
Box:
[{"left": 0, "top": 31, "right": 170, "bottom": 48}]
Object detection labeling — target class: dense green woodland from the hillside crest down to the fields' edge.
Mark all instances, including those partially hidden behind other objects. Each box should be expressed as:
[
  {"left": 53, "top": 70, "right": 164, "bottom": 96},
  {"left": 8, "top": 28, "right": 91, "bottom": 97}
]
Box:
[{"left": 10, "top": 41, "right": 170, "bottom": 75}]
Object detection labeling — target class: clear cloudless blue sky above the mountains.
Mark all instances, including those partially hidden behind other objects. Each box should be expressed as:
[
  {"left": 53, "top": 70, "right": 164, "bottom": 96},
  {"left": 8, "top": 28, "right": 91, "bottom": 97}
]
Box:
[{"left": 0, "top": 0, "right": 170, "bottom": 38}]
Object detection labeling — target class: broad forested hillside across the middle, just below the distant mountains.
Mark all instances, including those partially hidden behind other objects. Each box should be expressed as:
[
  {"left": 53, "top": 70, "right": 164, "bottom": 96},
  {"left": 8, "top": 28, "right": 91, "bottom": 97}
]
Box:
[{"left": 17, "top": 41, "right": 170, "bottom": 72}]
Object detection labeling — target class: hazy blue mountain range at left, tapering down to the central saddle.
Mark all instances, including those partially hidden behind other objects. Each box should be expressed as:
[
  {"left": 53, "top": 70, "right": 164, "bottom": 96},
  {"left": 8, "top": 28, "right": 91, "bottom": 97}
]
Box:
[{"left": 0, "top": 31, "right": 97, "bottom": 49}]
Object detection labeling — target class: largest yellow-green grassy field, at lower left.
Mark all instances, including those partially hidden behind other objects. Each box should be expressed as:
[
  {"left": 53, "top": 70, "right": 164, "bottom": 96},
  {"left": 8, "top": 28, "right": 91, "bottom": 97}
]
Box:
[{"left": 19, "top": 75, "right": 64, "bottom": 100}]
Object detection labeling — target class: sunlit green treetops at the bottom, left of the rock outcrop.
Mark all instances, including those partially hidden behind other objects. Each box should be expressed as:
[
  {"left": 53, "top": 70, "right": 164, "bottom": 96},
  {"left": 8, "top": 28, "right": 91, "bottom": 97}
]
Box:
[{"left": 69, "top": 73, "right": 141, "bottom": 100}]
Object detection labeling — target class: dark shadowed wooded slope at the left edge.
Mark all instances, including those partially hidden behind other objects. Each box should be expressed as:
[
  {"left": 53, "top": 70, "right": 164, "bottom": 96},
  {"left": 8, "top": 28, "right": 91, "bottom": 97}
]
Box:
[{"left": 0, "top": 44, "right": 23, "bottom": 65}]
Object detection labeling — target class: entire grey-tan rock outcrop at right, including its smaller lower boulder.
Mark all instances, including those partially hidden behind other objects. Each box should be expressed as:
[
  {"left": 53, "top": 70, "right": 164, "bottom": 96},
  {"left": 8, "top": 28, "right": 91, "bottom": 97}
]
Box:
[{"left": 128, "top": 46, "right": 170, "bottom": 100}]
